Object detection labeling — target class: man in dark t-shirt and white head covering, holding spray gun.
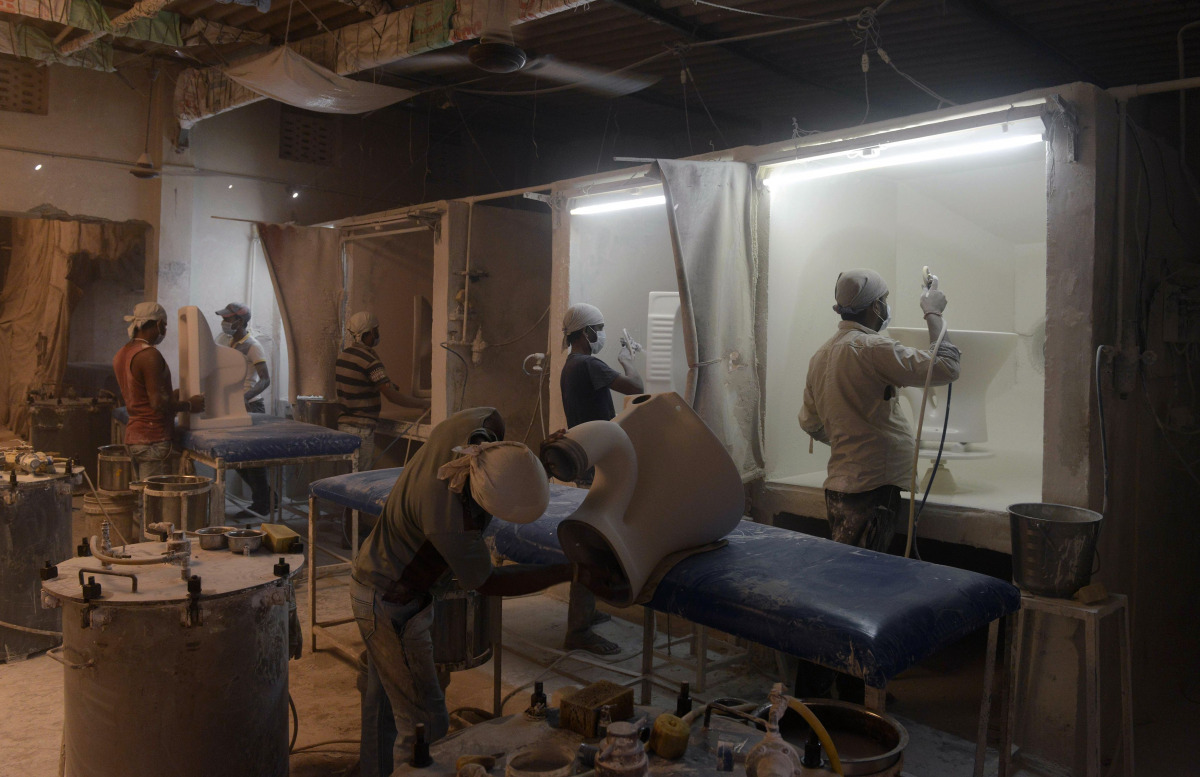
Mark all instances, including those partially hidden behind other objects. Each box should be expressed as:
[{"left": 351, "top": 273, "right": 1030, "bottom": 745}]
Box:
[{"left": 559, "top": 302, "right": 643, "bottom": 656}]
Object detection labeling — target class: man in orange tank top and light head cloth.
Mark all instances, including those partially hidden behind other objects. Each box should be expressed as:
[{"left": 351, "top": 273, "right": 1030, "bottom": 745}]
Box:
[{"left": 113, "top": 302, "right": 204, "bottom": 480}]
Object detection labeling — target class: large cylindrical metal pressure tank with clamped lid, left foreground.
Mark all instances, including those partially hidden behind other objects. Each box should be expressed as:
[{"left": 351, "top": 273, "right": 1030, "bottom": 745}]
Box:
[{"left": 42, "top": 537, "right": 304, "bottom": 777}]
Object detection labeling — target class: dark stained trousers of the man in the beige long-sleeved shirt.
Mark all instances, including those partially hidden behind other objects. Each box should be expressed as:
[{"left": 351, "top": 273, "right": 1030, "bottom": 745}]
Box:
[{"left": 796, "top": 486, "right": 900, "bottom": 704}]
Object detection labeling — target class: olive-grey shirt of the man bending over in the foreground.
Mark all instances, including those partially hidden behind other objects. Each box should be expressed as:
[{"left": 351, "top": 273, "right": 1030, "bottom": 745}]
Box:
[{"left": 353, "top": 408, "right": 506, "bottom": 595}]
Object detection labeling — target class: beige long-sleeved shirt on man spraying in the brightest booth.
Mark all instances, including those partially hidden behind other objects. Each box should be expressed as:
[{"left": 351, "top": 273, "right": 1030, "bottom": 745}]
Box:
[{"left": 800, "top": 321, "right": 959, "bottom": 494}]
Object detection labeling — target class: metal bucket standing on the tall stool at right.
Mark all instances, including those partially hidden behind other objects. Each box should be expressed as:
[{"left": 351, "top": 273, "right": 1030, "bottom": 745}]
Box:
[{"left": 1008, "top": 502, "right": 1104, "bottom": 598}]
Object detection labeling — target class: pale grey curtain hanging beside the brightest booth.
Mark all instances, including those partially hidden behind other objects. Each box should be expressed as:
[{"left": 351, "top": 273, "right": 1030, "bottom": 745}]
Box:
[{"left": 658, "top": 159, "right": 763, "bottom": 481}]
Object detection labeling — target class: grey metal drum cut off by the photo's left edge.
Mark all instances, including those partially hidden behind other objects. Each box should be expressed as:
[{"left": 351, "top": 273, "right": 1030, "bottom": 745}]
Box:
[{"left": 0, "top": 472, "right": 72, "bottom": 661}]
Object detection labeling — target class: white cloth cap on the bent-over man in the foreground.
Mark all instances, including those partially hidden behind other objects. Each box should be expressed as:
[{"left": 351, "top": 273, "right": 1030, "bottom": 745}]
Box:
[{"left": 438, "top": 442, "right": 550, "bottom": 523}]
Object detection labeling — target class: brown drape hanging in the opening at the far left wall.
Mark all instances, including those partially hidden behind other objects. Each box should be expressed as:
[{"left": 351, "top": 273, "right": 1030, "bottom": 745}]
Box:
[{"left": 0, "top": 218, "right": 148, "bottom": 439}]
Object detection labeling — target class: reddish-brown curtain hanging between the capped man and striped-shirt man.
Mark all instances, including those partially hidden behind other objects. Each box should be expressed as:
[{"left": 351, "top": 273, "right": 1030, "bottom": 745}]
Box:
[{"left": 257, "top": 224, "right": 346, "bottom": 404}]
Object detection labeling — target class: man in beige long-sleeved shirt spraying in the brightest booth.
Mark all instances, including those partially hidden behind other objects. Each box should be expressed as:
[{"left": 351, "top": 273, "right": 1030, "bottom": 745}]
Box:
[{"left": 796, "top": 270, "right": 959, "bottom": 704}]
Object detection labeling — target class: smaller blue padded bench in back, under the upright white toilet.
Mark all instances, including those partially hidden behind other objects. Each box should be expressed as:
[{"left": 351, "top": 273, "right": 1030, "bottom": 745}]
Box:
[{"left": 113, "top": 408, "right": 361, "bottom": 526}]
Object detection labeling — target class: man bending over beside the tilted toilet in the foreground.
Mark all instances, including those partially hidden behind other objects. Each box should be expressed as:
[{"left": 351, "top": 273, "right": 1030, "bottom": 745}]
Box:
[{"left": 350, "top": 408, "right": 571, "bottom": 777}]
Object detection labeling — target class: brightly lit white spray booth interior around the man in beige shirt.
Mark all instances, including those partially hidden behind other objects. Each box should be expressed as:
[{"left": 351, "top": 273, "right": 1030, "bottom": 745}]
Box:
[{"left": 764, "top": 120, "right": 1046, "bottom": 510}]
